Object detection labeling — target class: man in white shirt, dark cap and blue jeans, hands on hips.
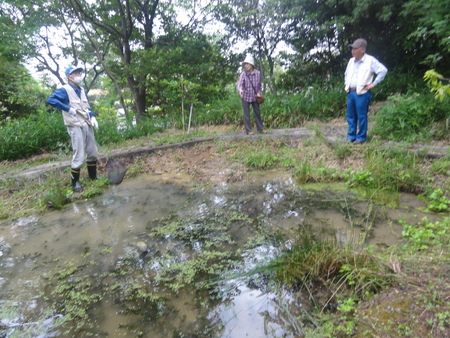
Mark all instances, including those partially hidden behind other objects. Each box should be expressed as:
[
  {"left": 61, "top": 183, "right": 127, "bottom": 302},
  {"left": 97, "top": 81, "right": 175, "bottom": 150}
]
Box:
[{"left": 345, "top": 39, "right": 387, "bottom": 144}]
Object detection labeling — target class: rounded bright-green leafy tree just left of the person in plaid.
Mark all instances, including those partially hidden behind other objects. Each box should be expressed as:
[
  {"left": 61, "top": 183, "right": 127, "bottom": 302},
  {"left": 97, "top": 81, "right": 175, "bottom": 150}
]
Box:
[{"left": 137, "top": 32, "right": 235, "bottom": 119}]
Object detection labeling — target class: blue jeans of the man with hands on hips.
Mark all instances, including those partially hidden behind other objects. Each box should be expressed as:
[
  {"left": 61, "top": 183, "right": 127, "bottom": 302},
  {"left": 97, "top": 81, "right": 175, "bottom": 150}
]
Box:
[{"left": 347, "top": 91, "right": 372, "bottom": 142}]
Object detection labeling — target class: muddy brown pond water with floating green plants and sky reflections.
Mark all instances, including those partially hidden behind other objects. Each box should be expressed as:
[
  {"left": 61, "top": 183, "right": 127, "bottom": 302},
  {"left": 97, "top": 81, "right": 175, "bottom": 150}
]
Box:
[{"left": 0, "top": 175, "right": 436, "bottom": 337}]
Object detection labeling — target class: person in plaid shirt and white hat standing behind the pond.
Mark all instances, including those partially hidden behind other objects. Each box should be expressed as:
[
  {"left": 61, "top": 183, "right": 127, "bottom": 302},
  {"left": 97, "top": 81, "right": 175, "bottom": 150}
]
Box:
[{"left": 238, "top": 55, "right": 265, "bottom": 135}]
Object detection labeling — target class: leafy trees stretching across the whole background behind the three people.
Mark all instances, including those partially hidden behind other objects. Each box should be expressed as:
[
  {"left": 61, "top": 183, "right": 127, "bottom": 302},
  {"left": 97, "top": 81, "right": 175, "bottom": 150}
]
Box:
[{"left": 0, "top": 0, "right": 450, "bottom": 122}]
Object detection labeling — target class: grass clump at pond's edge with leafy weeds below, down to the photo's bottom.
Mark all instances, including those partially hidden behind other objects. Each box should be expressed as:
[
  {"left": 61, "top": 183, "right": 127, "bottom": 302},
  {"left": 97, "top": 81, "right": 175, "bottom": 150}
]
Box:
[{"left": 268, "top": 228, "right": 398, "bottom": 337}]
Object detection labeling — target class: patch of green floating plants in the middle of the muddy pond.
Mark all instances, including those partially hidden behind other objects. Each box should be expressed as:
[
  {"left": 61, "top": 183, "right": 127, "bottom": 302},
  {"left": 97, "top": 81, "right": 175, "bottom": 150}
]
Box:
[{"left": 148, "top": 206, "right": 252, "bottom": 291}]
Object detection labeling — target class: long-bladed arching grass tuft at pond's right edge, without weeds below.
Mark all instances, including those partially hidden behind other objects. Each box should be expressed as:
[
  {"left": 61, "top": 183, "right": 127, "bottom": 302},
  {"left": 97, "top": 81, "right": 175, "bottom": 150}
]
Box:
[{"left": 273, "top": 231, "right": 394, "bottom": 298}]
